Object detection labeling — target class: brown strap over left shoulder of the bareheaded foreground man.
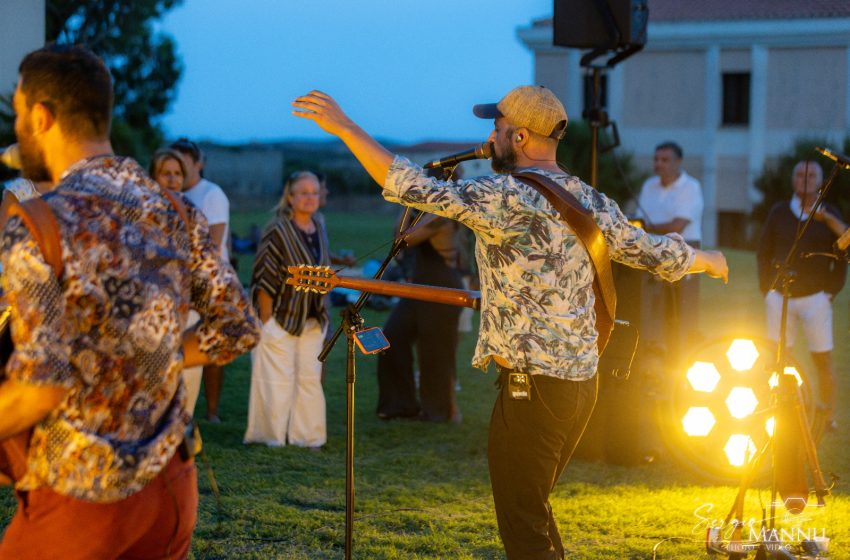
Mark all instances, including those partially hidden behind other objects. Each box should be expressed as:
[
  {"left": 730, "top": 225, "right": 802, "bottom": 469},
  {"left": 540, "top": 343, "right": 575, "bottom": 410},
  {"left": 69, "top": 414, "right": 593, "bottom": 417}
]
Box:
[{"left": 0, "top": 191, "right": 64, "bottom": 278}]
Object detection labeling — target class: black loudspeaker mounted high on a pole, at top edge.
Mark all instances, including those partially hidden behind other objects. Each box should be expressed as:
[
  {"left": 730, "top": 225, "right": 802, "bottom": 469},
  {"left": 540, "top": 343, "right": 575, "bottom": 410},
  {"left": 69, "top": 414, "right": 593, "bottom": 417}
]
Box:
[{"left": 552, "top": 0, "right": 649, "bottom": 50}]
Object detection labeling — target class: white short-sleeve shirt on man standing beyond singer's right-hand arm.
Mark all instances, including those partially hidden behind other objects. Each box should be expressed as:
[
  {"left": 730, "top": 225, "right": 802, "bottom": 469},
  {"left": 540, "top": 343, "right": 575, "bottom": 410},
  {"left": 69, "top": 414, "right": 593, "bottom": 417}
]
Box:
[{"left": 638, "top": 171, "right": 703, "bottom": 241}]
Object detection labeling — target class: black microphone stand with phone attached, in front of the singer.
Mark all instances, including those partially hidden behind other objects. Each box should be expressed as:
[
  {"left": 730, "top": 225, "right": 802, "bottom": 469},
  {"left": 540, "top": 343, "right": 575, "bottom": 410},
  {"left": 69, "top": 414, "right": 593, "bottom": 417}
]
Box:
[{"left": 319, "top": 164, "right": 457, "bottom": 560}]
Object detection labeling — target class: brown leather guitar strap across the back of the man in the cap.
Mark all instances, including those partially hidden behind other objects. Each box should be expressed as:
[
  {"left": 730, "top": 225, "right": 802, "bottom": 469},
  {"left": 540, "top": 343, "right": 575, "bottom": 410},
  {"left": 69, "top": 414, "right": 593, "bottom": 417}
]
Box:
[{"left": 512, "top": 171, "right": 617, "bottom": 354}]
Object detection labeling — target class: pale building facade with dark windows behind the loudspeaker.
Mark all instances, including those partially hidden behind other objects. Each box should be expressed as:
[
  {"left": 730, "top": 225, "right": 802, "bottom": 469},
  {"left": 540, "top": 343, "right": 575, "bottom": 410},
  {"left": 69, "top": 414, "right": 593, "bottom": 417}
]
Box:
[{"left": 518, "top": 0, "right": 850, "bottom": 245}]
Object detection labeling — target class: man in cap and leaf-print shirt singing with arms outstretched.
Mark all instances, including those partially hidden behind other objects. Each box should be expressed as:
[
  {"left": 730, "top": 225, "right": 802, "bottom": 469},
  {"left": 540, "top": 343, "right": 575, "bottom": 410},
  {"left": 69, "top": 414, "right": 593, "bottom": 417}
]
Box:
[{"left": 293, "top": 86, "right": 728, "bottom": 559}]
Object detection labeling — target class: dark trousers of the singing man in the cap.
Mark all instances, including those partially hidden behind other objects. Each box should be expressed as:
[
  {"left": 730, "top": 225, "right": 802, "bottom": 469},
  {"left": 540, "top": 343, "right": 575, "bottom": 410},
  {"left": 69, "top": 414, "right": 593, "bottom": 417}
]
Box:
[{"left": 487, "top": 373, "right": 597, "bottom": 560}]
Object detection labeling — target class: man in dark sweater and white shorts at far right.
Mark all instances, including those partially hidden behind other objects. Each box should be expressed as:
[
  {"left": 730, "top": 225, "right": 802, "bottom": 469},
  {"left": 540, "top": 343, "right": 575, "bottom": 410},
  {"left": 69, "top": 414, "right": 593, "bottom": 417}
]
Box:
[{"left": 756, "top": 161, "right": 847, "bottom": 429}]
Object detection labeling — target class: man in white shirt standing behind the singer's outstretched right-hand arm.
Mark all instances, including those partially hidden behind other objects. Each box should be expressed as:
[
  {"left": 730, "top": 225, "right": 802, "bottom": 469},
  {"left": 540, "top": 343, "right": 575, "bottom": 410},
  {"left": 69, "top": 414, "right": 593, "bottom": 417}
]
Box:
[{"left": 638, "top": 142, "right": 703, "bottom": 358}]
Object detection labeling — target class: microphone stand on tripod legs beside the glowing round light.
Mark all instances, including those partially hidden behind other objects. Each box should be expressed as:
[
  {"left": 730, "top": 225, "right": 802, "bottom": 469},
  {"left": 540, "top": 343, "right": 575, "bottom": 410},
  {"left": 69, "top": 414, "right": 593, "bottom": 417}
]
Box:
[{"left": 712, "top": 155, "right": 848, "bottom": 560}]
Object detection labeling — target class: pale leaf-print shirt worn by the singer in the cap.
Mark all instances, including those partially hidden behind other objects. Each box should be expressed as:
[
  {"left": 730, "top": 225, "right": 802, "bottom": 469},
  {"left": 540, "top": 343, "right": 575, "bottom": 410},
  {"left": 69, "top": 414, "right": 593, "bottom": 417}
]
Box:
[{"left": 383, "top": 157, "right": 694, "bottom": 380}]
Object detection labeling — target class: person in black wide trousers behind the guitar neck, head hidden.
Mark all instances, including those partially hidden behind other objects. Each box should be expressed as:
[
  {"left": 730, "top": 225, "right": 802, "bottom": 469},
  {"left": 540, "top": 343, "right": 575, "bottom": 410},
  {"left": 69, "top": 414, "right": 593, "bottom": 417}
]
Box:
[{"left": 377, "top": 216, "right": 463, "bottom": 422}]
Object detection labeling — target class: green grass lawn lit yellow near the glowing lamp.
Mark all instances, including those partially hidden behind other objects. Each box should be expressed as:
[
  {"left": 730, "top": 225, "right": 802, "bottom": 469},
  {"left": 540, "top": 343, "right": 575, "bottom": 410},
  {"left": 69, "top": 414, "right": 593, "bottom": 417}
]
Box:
[{"left": 0, "top": 208, "right": 850, "bottom": 560}]
